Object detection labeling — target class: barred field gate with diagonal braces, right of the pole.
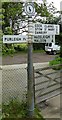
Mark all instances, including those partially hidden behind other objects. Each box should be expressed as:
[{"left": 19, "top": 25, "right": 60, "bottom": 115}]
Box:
[{"left": 35, "top": 64, "right": 62, "bottom": 104}]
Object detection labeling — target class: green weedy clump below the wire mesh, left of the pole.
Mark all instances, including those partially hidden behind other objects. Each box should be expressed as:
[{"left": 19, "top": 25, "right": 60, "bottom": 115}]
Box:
[{"left": 2, "top": 99, "right": 27, "bottom": 118}]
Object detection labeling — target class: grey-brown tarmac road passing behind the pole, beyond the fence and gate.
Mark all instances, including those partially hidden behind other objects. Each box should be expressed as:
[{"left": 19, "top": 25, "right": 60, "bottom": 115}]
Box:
[{"left": 0, "top": 53, "right": 56, "bottom": 65}]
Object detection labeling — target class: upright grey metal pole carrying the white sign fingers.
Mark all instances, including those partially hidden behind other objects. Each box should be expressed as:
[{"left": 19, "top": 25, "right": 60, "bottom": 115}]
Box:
[{"left": 27, "top": 18, "right": 34, "bottom": 118}]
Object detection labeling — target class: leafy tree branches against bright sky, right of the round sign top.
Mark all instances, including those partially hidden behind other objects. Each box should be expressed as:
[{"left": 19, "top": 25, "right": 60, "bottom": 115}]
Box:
[{"left": 35, "top": 0, "right": 57, "bottom": 23}]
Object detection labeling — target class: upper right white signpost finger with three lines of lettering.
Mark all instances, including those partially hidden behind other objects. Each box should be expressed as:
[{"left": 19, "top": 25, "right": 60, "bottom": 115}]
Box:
[{"left": 33, "top": 23, "right": 59, "bottom": 35}]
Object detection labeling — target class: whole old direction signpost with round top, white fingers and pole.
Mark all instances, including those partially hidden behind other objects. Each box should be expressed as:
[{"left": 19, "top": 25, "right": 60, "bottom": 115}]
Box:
[{"left": 3, "top": 2, "right": 59, "bottom": 117}]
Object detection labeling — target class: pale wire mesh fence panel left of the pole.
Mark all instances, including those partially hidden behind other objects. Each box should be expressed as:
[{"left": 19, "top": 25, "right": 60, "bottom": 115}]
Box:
[{"left": 2, "top": 67, "right": 27, "bottom": 103}]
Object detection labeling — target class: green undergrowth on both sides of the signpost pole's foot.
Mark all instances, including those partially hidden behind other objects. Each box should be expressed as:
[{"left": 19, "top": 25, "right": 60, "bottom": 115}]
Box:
[{"left": 2, "top": 99, "right": 44, "bottom": 120}]
